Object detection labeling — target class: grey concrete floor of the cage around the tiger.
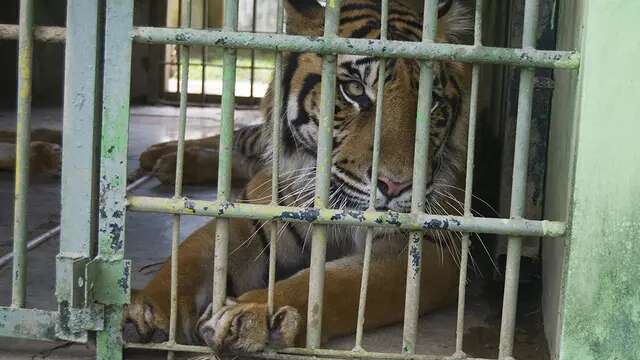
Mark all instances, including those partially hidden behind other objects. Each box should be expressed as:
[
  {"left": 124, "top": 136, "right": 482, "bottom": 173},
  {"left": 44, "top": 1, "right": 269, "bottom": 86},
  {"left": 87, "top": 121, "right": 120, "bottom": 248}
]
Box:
[{"left": 0, "top": 107, "right": 548, "bottom": 360}]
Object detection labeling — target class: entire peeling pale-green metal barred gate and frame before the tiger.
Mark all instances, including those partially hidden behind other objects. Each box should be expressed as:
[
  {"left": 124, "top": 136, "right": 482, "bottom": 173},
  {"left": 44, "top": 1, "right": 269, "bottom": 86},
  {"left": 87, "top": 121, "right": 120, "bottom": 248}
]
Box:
[{"left": 0, "top": 0, "right": 580, "bottom": 359}]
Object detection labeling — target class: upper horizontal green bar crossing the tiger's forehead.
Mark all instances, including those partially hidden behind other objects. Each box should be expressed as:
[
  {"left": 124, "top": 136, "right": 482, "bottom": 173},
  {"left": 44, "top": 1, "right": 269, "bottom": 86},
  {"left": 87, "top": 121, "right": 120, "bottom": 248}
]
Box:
[{"left": 132, "top": 27, "right": 580, "bottom": 69}]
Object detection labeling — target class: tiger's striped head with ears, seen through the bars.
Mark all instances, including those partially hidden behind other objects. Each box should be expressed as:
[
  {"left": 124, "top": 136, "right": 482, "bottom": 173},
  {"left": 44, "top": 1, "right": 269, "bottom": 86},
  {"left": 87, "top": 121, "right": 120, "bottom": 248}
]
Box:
[{"left": 265, "top": 0, "right": 472, "bottom": 212}]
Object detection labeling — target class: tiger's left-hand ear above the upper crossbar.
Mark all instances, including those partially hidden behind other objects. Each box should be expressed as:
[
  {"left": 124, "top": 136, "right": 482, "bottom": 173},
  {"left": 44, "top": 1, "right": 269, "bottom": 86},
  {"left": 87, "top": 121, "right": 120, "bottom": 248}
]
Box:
[{"left": 285, "top": 0, "right": 325, "bottom": 36}]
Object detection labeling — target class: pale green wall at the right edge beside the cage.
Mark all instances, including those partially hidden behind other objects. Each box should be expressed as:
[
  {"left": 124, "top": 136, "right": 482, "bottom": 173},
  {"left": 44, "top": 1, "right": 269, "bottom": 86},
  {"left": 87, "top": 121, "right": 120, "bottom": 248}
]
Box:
[{"left": 545, "top": 0, "right": 640, "bottom": 360}]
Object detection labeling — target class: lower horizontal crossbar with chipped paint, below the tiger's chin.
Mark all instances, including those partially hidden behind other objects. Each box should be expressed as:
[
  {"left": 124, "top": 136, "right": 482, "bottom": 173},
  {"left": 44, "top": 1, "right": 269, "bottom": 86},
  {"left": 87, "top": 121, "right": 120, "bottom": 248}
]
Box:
[{"left": 127, "top": 196, "right": 565, "bottom": 237}]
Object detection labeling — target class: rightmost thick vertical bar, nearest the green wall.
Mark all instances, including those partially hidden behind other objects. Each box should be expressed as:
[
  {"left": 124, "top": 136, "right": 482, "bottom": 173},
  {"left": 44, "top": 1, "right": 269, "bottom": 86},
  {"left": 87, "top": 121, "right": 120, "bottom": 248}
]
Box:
[{"left": 499, "top": 0, "right": 539, "bottom": 359}]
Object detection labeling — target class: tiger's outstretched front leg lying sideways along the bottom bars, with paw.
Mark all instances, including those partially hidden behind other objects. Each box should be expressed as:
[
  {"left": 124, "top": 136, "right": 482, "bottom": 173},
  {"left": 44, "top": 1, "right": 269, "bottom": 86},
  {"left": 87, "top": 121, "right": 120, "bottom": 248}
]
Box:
[{"left": 197, "top": 241, "right": 458, "bottom": 352}]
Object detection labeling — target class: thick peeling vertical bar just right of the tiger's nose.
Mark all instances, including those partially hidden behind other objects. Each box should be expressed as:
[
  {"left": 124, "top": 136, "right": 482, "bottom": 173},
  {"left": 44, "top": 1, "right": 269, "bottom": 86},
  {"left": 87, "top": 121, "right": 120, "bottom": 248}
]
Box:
[{"left": 402, "top": 0, "right": 438, "bottom": 354}]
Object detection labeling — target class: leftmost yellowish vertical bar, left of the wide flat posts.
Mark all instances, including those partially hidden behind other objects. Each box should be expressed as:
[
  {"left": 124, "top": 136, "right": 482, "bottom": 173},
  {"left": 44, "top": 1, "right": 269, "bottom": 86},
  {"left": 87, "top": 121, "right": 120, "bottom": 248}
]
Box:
[{"left": 11, "top": 0, "right": 33, "bottom": 307}]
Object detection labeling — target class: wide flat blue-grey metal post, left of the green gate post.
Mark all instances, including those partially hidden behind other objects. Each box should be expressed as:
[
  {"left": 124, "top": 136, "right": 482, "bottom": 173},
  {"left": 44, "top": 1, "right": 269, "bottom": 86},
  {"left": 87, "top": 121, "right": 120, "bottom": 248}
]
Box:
[{"left": 56, "top": 0, "right": 102, "bottom": 270}]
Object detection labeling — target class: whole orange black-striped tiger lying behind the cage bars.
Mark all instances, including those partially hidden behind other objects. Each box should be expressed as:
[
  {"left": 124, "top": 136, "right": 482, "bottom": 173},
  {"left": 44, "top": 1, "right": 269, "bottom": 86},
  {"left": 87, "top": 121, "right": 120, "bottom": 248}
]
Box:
[{"left": 125, "top": 0, "right": 473, "bottom": 352}]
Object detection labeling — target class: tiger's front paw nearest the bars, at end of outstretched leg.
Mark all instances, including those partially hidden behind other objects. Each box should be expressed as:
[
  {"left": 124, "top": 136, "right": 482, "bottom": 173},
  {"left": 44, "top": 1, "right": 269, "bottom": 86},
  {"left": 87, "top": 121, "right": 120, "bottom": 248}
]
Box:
[{"left": 197, "top": 303, "right": 302, "bottom": 352}]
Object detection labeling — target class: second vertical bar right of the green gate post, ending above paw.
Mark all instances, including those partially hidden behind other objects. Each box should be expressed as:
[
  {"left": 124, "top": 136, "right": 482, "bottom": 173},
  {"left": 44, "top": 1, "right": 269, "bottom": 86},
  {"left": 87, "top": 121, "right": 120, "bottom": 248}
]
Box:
[{"left": 212, "top": 0, "right": 238, "bottom": 311}]
